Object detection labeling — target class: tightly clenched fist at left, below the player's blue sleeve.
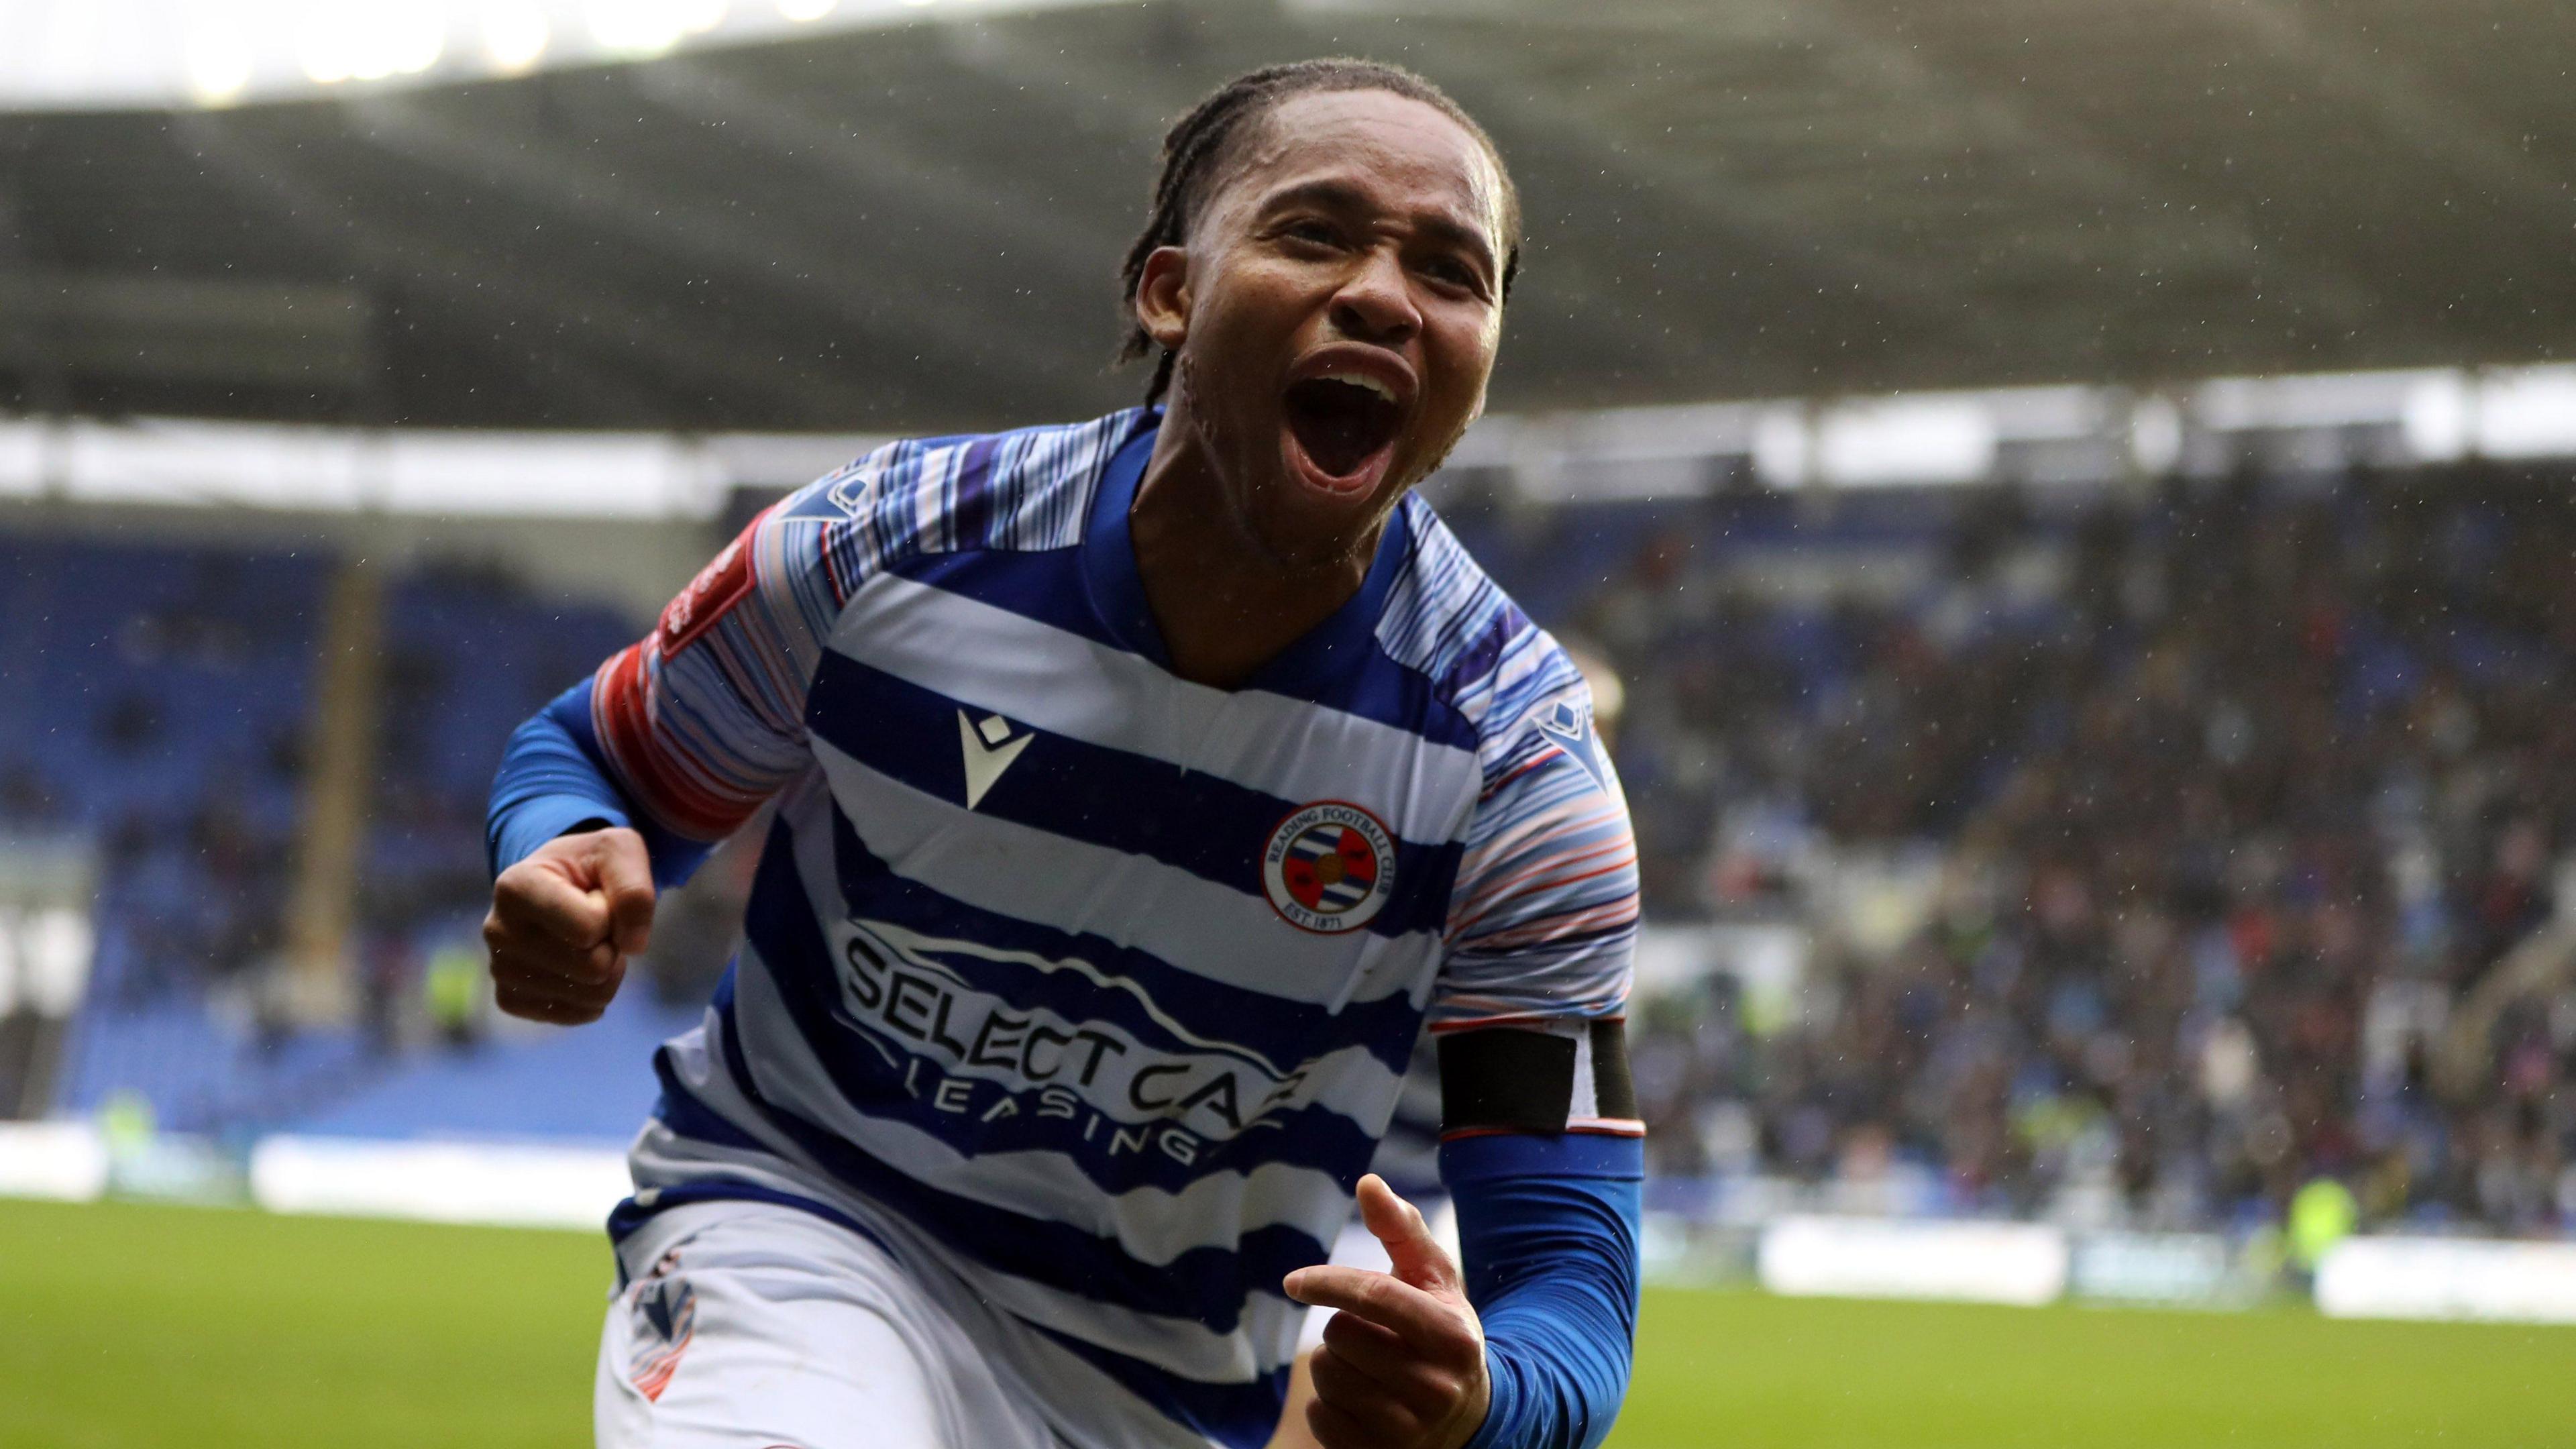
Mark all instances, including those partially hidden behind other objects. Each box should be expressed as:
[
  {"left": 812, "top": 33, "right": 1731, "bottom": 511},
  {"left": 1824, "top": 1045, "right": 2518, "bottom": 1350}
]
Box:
[{"left": 484, "top": 828, "right": 652, "bottom": 1026}]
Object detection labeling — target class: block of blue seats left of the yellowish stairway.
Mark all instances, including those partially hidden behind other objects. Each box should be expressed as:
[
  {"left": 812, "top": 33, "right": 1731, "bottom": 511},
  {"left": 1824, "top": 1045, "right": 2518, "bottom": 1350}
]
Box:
[{"left": 0, "top": 536, "right": 345, "bottom": 1127}]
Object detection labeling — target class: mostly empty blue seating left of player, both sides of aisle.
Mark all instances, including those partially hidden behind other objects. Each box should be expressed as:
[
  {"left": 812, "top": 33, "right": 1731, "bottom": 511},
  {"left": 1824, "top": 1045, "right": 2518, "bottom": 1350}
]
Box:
[{"left": 0, "top": 534, "right": 667, "bottom": 1137}]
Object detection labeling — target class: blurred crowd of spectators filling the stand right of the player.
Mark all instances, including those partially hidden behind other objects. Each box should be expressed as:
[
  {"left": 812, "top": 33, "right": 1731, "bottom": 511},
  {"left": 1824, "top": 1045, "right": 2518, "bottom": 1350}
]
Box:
[{"left": 1576, "top": 467, "right": 2576, "bottom": 1230}]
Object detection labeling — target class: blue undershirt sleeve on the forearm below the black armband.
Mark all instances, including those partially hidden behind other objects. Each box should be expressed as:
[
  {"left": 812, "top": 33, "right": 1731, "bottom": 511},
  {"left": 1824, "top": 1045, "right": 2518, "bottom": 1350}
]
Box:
[{"left": 1440, "top": 1132, "right": 1646, "bottom": 1449}]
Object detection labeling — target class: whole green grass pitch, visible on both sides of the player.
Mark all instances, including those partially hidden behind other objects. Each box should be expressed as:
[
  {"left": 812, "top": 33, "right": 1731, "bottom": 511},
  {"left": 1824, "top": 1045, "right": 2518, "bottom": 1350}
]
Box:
[{"left": 0, "top": 1201, "right": 2576, "bottom": 1449}]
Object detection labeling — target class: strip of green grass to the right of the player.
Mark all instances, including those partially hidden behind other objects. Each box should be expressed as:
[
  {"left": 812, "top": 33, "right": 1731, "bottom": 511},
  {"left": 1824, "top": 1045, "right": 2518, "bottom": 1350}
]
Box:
[{"left": 1610, "top": 1273, "right": 2576, "bottom": 1449}]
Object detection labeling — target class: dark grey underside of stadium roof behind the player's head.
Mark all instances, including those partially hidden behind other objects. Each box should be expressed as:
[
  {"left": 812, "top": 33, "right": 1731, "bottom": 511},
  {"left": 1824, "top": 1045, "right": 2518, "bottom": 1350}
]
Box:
[{"left": 0, "top": 0, "right": 2576, "bottom": 431}]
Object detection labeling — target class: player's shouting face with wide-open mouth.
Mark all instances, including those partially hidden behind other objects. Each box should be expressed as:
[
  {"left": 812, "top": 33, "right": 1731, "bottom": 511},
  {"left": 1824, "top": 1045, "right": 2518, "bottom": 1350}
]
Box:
[{"left": 1177, "top": 91, "right": 1502, "bottom": 562}]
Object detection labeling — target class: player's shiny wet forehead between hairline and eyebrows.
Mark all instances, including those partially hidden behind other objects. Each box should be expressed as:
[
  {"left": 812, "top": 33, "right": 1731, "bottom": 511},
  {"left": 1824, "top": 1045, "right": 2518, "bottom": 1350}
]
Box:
[{"left": 1226, "top": 91, "right": 1502, "bottom": 239}]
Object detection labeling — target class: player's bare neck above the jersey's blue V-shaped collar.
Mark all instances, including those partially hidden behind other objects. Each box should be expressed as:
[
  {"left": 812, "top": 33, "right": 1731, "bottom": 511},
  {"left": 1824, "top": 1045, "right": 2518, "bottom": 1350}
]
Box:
[{"left": 1128, "top": 389, "right": 1386, "bottom": 688}]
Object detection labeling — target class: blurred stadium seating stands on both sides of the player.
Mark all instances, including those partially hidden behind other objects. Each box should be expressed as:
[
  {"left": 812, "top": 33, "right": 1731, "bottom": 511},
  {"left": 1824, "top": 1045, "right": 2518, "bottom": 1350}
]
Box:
[{"left": 20, "top": 453, "right": 2576, "bottom": 1230}]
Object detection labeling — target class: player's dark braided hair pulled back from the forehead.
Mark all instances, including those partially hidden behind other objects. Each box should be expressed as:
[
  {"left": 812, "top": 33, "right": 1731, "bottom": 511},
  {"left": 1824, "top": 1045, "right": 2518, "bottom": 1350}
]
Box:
[{"left": 1118, "top": 57, "right": 1520, "bottom": 405}]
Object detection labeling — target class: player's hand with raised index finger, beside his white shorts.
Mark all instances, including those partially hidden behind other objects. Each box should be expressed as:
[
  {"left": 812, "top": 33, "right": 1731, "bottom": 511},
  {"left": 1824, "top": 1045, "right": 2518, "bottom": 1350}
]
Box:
[{"left": 1283, "top": 1173, "right": 1494, "bottom": 1449}]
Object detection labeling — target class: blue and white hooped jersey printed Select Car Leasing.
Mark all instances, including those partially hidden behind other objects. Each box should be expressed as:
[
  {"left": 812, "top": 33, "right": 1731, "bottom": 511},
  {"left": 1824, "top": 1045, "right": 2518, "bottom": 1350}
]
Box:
[{"left": 592, "top": 410, "right": 1635, "bottom": 1446}]
